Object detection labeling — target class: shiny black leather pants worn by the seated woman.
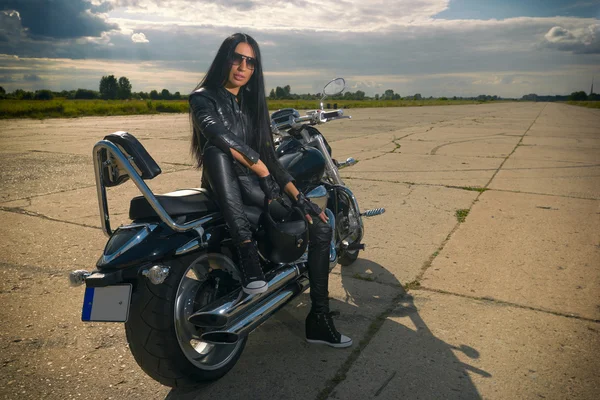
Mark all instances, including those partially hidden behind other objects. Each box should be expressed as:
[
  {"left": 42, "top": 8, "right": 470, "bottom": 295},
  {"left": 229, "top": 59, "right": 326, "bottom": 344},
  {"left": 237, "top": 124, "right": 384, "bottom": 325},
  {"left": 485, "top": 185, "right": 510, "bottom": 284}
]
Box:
[{"left": 202, "top": 146, "right": 332, "bottom": 313}]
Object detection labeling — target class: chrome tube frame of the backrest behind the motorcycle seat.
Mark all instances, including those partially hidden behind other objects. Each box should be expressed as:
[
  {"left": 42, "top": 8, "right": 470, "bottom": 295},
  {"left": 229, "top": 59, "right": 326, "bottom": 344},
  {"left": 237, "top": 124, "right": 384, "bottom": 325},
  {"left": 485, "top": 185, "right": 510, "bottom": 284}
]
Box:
[{"left": 92, "top": 132, "right": 212, "bottom": 237}]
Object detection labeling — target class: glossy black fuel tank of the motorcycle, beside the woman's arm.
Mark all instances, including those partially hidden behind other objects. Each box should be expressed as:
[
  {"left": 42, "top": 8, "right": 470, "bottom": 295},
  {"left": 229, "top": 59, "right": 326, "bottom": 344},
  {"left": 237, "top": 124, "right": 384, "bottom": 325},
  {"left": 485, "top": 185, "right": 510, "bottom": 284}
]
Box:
[{"left": 277, "top": 137, "right": 325, "bottom": 186}]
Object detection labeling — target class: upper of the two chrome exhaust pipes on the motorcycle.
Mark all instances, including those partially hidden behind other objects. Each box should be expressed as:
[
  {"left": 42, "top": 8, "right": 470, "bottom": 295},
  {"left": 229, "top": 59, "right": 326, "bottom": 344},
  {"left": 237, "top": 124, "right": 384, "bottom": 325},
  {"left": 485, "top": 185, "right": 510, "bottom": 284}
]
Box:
[{"left": 188, "top": 264, "right": 304, "bottom": 329}]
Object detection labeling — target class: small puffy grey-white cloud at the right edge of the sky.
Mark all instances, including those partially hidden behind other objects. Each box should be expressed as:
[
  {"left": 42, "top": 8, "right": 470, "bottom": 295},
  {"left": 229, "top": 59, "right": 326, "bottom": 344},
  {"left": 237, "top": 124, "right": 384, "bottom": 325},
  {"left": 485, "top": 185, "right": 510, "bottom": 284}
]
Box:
[{"left": 543, "top": 24, "right": 600, "bottom": 54}]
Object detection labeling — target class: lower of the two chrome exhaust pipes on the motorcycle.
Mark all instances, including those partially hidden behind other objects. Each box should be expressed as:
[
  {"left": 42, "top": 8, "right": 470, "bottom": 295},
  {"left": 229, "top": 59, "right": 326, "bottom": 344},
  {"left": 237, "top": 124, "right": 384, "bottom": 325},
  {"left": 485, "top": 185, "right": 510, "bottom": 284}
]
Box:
[{"left": 201, "top": 277, "right": 309, "bottom": 344}]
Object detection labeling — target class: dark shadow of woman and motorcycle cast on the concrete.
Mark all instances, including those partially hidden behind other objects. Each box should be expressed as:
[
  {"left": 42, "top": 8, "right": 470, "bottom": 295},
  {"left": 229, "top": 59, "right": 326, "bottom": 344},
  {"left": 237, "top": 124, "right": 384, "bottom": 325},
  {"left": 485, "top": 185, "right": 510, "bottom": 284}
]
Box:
[{"left": 166, "top": 259, "right": 490, "bottom": 400}]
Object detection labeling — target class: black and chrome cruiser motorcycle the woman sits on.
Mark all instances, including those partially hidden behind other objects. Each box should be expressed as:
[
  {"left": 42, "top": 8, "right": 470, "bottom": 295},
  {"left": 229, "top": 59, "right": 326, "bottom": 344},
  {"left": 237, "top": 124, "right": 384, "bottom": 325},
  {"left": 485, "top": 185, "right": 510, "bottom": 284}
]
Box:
[{"left": 69, "top": 78, "right": 385, "bottom": 387}]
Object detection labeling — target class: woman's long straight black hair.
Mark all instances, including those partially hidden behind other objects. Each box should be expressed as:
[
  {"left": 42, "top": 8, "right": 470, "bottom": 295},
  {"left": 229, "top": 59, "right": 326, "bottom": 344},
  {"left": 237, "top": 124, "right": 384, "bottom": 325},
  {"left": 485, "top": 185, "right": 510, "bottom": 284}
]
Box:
[{"left": 190, "top": 33, "right": 273, "bottom": 168}]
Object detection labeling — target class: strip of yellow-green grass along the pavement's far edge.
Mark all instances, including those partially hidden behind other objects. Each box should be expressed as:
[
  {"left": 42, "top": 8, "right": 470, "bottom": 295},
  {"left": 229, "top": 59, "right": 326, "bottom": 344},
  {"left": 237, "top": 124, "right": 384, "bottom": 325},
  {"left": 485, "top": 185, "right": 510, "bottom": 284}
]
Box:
[{"left": 0, "top": 99, "right": 496, "bottom": 119}]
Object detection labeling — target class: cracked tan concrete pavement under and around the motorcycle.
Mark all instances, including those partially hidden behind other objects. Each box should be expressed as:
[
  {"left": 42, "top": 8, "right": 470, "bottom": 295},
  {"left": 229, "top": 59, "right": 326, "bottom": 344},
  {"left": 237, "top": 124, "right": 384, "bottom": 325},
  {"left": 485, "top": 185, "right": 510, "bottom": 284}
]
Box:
[{"left": 0, "top": 103, "right": 600, "bottom": 400}]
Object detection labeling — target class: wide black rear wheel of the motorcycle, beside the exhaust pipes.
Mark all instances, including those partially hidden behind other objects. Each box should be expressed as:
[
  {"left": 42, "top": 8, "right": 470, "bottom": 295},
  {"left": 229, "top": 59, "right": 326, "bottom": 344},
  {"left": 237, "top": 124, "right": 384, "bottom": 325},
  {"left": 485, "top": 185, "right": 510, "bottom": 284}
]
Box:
[{"left": 125, "top": 254, "right": 247, "bottom": 387}]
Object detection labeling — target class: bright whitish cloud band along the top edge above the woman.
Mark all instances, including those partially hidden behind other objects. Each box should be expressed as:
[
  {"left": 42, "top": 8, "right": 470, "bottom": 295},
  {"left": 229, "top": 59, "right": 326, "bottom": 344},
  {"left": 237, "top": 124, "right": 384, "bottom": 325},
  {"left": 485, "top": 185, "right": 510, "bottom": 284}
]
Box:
[{"left": 109, "top": 0, "right": 449, "bottom": 32}]
